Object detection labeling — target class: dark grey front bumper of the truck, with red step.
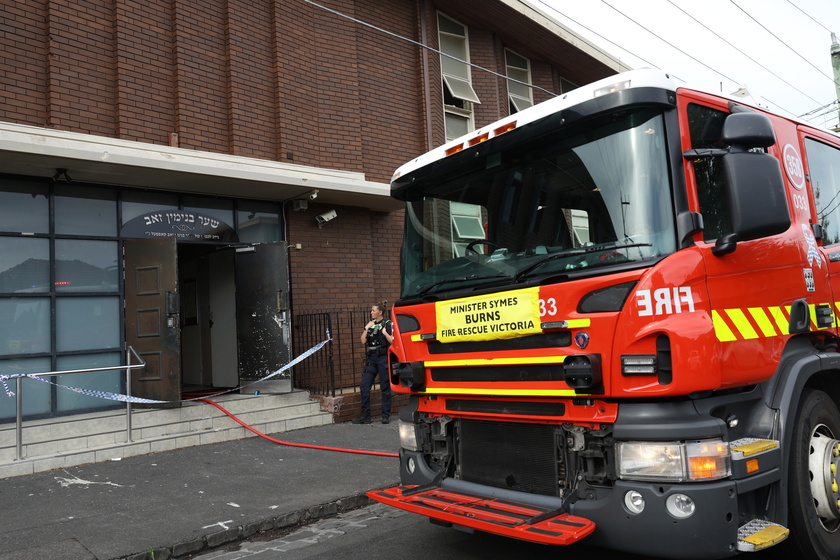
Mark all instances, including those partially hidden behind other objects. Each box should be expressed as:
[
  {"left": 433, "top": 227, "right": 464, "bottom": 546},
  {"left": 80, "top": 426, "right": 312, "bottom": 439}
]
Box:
[{"left": 382, "top": 449, "right": 740, "bottom": 560}]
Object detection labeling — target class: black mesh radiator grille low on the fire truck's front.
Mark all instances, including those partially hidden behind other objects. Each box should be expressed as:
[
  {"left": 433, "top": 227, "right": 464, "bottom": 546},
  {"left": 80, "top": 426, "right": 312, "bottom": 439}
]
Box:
[{"left": 459, "top": 420, "right": 562, "bottom": 496}]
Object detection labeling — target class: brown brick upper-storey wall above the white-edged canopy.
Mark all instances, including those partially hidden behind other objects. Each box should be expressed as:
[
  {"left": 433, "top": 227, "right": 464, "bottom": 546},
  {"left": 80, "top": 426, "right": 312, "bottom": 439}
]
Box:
[{"left": 0, "top": 0, "right": 612, "bottom": 173}]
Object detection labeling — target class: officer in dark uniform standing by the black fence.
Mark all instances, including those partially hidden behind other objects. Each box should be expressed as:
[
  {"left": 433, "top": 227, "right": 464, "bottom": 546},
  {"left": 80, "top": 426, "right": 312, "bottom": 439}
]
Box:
[{"left": 353, "top": 303, "right": 394, "bottom": 424}]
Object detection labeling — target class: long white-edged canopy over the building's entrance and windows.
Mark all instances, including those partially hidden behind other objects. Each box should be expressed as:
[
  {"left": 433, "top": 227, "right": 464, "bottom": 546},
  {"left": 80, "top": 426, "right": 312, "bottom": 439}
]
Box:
[{"left": 0, "top": 122, "right": 402, "bottom": 212}]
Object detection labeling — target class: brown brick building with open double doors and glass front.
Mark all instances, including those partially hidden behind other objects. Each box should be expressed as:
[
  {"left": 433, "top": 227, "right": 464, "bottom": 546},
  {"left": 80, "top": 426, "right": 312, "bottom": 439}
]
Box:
[{"left": 0, "top": 0, "right": 626, "bottom": 421}]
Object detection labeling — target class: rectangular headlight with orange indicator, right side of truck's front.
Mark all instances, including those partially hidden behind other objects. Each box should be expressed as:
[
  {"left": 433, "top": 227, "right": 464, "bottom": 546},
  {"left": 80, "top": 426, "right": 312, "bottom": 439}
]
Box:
[{"left": 617, "top": 439, "right": 732, "bottom": 482}]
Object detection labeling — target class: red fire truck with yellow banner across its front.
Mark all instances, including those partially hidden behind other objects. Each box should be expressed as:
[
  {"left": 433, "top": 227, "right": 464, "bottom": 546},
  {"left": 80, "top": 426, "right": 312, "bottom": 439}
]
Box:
[{"left": 369, "top": 70, "right": 840, "bottom": 560}]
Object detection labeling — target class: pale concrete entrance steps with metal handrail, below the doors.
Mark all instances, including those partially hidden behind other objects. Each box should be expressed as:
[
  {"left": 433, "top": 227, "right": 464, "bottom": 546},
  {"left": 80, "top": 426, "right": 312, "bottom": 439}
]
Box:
[{"left": 0, "top": 391, "right": 333, "bottom": 478}]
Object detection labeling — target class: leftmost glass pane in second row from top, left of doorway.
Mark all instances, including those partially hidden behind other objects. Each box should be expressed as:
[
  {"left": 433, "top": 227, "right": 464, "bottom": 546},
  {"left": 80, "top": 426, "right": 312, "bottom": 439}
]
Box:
[{"left": 0, "top": 237, "right": 50, "bottom": 293}]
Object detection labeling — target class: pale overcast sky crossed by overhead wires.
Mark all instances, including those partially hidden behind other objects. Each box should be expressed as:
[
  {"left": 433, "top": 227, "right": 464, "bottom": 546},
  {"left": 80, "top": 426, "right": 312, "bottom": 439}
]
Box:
[{"left": 526, "top": 0, "right": 840, "bottom": 128}]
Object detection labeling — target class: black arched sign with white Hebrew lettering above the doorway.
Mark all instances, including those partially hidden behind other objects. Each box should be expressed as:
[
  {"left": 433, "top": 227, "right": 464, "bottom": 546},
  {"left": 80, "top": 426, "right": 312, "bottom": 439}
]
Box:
[{"left": 120, "top": 210, "right": 239, "bottom": 242}]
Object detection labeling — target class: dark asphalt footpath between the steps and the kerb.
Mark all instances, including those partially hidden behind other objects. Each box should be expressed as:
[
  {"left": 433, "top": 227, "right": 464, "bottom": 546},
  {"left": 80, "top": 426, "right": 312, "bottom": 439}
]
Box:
[{"left": 0, "top": 419, "right": 399, "bottom": 560}]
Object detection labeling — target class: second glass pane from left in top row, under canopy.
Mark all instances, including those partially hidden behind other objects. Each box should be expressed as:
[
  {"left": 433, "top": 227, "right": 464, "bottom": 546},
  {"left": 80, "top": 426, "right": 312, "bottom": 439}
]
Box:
[{"left": 55, "top": 185, "right": 117, "bottom": 237}]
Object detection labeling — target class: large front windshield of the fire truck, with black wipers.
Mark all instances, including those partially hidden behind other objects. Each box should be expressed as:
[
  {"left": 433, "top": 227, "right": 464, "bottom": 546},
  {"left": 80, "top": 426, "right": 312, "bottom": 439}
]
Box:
[{"left": 402, "top": 108, "right": 676, "bottom": 297}]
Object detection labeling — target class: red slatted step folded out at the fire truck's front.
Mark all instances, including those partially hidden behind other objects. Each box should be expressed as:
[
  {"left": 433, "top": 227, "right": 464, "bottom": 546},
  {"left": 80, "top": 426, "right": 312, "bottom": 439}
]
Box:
[{"left": 367, "top": 486, "right": 595, "bottom": 545}]
